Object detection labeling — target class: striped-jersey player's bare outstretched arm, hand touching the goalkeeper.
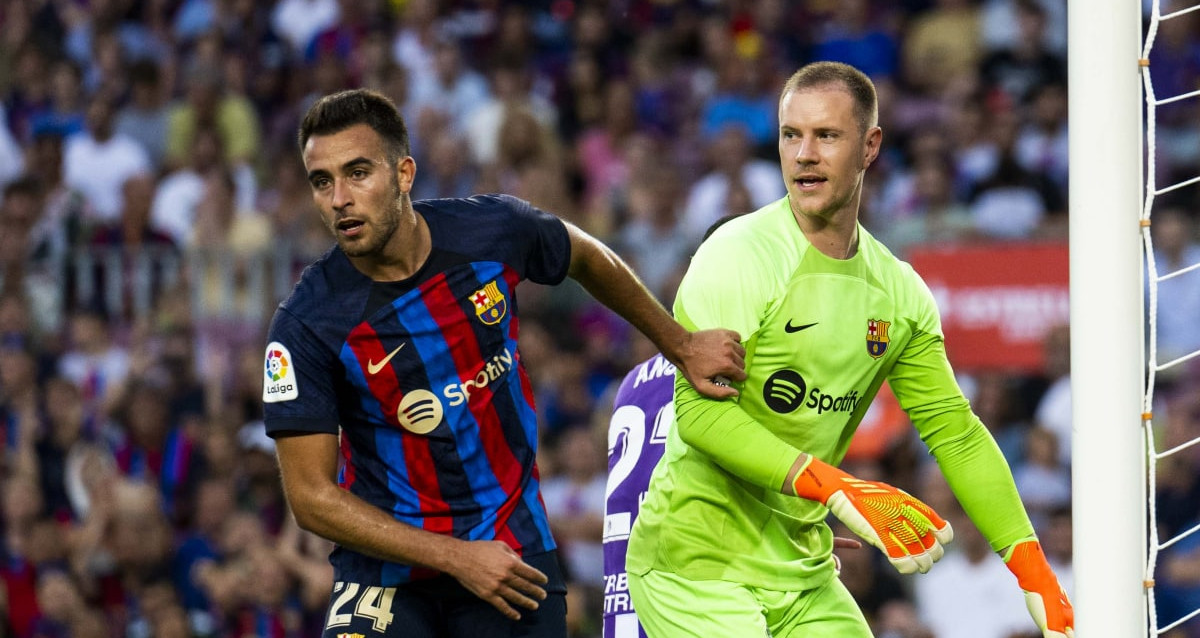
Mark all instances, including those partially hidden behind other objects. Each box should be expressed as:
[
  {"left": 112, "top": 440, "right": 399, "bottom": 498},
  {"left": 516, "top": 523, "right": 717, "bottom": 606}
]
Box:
[{"left": 566, "top": 224, "right": 746, "bottom": 398}]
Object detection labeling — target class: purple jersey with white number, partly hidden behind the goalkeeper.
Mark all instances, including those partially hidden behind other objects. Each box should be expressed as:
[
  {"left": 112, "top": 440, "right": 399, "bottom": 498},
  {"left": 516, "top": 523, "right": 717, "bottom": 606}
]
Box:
[{"left": 604, "top": 355, "right": 676, "bottom": 638}]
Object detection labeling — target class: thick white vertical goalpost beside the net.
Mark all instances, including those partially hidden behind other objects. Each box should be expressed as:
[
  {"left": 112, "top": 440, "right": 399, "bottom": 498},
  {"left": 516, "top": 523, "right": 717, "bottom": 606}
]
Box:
[{"left": 1067, "top": 0, "right": 1148, "bottom": 638}]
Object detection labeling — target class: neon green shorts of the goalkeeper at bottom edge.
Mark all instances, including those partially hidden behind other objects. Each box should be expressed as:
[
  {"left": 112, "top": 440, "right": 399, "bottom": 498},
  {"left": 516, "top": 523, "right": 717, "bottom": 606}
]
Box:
[{"left": 629, "top": 570, "right": 871, "bottom": 638}]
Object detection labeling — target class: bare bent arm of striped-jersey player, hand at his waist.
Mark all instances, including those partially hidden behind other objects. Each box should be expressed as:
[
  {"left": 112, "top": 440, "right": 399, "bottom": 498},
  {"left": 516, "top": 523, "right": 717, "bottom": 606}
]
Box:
[{"left": 275, "top": 434, "right": 547, "bottom": 620}]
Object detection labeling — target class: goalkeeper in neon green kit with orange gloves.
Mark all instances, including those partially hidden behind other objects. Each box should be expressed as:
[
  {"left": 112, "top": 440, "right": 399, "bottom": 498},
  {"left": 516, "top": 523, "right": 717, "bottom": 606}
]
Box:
[{"left": 626, "top": 62, "right": 1074, "bottom": 638}]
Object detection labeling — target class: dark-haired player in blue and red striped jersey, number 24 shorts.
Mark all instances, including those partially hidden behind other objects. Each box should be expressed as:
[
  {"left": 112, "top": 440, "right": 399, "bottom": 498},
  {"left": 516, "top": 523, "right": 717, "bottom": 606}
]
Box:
[{"left": 263, "top": 90, "right": 744, "bottom": 638}]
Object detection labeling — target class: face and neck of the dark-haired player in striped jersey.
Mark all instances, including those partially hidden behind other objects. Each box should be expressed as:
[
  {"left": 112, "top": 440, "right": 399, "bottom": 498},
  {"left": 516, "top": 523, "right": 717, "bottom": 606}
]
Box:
[{"left": 304, "top": 124, "right": 430, "bottom": 281}]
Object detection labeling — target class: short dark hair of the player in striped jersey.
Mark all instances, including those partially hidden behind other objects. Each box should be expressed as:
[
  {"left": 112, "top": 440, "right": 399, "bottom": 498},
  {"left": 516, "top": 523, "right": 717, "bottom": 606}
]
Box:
[{"left": 300, "top": 89, "right": 408, "bottom": 164}]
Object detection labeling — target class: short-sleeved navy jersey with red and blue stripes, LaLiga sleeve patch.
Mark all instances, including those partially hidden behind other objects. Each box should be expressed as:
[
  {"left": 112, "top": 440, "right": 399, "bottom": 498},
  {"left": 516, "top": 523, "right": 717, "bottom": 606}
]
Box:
[{"left": 263, "top": 195, "right": 570, "bottom": 586}]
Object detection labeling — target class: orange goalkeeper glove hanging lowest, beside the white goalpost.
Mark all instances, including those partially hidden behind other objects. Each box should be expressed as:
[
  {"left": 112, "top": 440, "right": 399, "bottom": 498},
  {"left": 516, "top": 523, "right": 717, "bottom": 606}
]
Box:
[{"left": 1004, "top": 540, "right": 1075, "bottom": 638}]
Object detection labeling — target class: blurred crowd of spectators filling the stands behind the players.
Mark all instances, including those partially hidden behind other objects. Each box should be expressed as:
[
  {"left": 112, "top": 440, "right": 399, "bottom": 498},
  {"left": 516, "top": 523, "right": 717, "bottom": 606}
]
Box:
[{"left": 0, "top": 0, "right": 1200, "bottom": 638}]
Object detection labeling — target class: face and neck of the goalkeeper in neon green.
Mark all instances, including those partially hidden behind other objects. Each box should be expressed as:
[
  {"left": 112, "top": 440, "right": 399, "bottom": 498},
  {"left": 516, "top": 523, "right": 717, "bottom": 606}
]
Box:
[{"left": 779, "top": 84, "right": 883, "bottom": 259}]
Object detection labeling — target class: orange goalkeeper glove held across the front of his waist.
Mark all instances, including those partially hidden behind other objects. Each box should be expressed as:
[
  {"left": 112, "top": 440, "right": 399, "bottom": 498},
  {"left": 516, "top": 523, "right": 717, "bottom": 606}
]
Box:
[{"left": 792, "top": 455, "right": 954, "bottom": 573}]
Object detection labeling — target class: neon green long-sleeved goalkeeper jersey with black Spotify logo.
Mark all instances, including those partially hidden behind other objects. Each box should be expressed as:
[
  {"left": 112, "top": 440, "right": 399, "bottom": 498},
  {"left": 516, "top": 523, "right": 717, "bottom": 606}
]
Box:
[{"left": 626, "top": 198, "right": 1033, "bottom": 591}]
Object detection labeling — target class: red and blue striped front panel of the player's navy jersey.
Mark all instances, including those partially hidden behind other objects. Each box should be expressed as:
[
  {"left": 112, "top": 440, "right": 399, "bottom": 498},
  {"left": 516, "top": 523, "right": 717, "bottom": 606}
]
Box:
[{"left": 340, "top": 261, "right": 554, "bottom": 584}]
